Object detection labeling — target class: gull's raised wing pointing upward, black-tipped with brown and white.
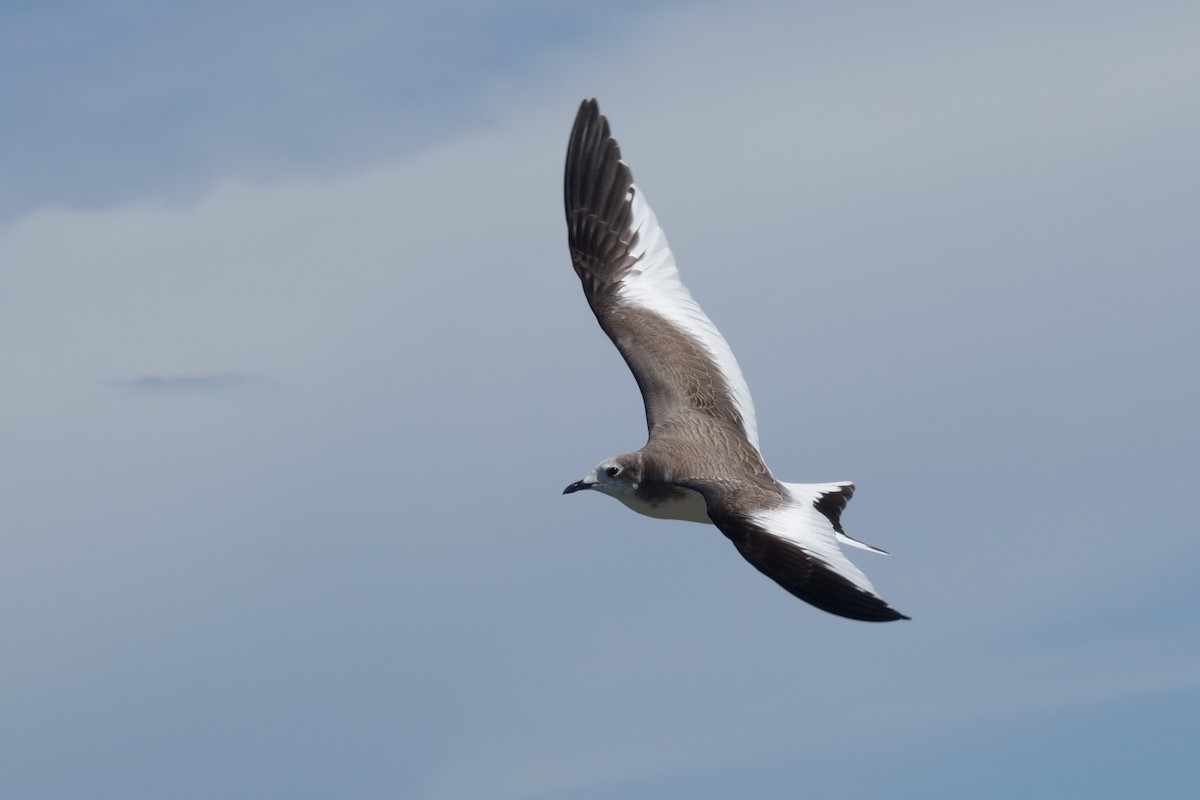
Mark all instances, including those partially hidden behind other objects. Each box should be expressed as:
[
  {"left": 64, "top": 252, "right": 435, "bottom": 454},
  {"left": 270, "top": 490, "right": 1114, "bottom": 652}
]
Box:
[{"left": 564, "top": 100, "right": 758, "bottom": 450}]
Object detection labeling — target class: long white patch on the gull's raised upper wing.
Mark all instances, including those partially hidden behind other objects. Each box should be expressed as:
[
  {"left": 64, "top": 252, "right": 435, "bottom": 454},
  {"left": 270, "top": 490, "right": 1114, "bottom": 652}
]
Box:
[{"left": 619, "top": 184, "right": 758, "bottom": 453}]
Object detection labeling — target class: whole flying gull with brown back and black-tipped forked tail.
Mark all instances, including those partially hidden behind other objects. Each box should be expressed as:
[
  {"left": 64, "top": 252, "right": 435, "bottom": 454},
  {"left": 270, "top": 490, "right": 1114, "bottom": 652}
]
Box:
[{"left": 563, "top": 100, "right": 908, "bottom": 622}]
